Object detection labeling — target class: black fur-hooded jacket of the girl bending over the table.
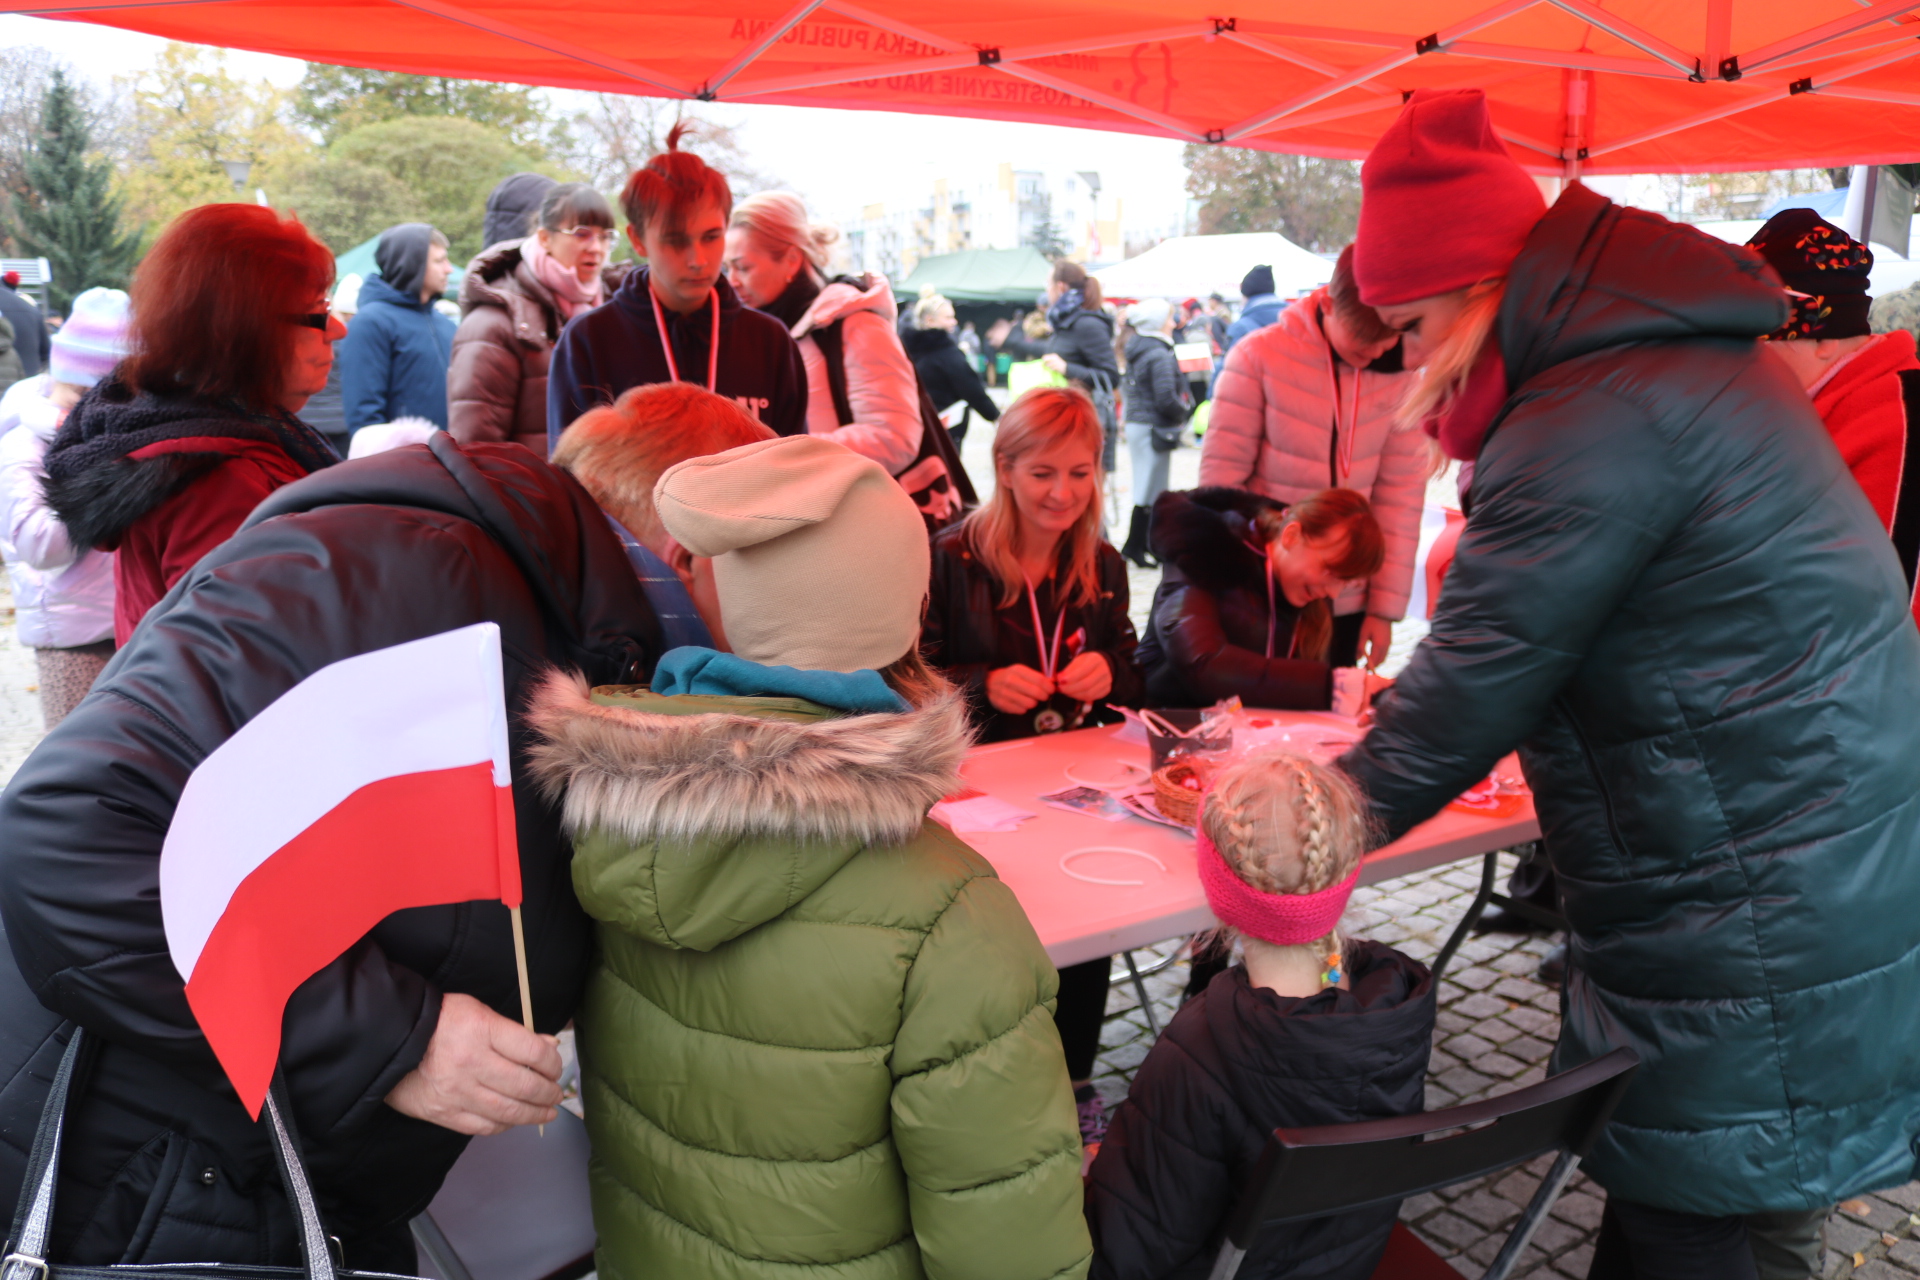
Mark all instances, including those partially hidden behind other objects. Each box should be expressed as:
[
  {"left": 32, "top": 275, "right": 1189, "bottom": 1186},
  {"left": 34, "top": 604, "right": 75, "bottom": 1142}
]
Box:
[{"left": 1140, "top": 486, "right": 1332, "bottom": 712}]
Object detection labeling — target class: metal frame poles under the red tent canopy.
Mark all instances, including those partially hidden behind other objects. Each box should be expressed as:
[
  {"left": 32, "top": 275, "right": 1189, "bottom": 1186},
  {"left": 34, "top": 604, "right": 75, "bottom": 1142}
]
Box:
[{"left": 15, "top": 0, "right": 1920, "bottom": 178}]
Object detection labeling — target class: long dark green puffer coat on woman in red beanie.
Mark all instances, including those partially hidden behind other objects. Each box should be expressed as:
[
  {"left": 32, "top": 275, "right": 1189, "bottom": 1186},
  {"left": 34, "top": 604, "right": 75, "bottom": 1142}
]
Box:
[{"left": 1344, "top": 186, "right": 1920, "bottom": 1215}]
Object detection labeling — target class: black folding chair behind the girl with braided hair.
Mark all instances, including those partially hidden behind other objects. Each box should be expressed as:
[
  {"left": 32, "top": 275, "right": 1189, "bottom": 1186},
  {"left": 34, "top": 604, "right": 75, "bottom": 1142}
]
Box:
[{"left": 1212, "top": 1050, "right": 1640, "bottom": 1280}]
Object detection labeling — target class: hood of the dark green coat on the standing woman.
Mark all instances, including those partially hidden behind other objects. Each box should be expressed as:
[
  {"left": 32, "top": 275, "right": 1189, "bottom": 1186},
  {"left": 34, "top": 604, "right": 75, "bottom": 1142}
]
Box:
[{"left": 1500, "top": 186, "right": 1788, "bottom": 388}]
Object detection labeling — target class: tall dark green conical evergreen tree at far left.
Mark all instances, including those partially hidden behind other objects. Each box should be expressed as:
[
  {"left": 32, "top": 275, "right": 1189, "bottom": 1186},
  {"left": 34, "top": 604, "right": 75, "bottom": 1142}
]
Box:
[{"left": 17, "top": 67, "right": 140, "bottom": 315}]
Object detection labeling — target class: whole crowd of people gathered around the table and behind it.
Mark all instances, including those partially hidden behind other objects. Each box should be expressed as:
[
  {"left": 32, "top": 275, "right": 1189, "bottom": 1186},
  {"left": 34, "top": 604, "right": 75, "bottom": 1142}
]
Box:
[{"left": 0, "top": 90, "right": 1920, "bottom": 1280}]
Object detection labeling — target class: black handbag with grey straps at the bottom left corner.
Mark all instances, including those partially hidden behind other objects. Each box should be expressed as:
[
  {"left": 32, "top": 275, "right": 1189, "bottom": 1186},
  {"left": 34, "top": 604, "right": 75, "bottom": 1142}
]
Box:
[{"left": 0, "top": 1027, "right": 417, "bottom": 1280}]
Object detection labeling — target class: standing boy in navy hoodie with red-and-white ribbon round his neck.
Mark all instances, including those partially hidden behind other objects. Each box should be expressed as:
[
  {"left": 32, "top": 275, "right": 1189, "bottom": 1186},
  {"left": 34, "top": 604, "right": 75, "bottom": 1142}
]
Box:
[{"left": 547, "top": 121, "right": 806, "bottom": 447}]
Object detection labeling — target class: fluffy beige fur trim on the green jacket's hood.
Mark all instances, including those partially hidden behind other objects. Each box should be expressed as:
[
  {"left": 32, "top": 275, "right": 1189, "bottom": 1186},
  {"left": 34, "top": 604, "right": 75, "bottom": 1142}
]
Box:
[{"left": 526, "top": 672, "right": 970, "bottom": 844}]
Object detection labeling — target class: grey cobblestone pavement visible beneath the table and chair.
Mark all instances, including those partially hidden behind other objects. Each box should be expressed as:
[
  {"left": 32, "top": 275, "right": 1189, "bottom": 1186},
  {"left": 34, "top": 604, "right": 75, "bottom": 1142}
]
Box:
[{"left": 1094, "top": 856, "right": 1920, "bottom": 1280}]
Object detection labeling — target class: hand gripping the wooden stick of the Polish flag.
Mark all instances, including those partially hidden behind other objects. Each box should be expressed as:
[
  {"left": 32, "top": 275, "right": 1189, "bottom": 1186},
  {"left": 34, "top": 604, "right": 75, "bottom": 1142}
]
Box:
[{"left": 386, "top": 994, "right": 561, "bottom": 1138}]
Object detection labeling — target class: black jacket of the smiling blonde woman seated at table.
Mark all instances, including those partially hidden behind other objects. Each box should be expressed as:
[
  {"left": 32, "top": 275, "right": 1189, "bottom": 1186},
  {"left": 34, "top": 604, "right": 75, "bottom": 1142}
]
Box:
[{"left": 920, "top": 524, "right": 1140, "bottom": 743}]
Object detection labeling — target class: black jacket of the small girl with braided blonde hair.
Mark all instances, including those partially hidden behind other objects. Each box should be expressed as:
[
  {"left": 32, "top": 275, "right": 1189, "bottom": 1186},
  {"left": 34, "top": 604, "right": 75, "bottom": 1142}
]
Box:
[{"left": 1087, "top": 942, "right": 1434, "bottom": 1280}]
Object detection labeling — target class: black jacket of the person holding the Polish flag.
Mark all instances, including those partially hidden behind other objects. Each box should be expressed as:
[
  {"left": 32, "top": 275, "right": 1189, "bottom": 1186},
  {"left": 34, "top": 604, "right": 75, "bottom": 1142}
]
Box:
[{"left": 0, "top": 434, "right": 659, "bottom": 1274}]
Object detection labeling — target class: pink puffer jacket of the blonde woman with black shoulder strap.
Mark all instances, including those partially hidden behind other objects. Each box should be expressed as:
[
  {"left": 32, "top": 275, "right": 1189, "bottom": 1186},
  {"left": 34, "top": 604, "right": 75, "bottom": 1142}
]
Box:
[{"left": 793, "top": 273, "right": 922, "bottom": 476}]
